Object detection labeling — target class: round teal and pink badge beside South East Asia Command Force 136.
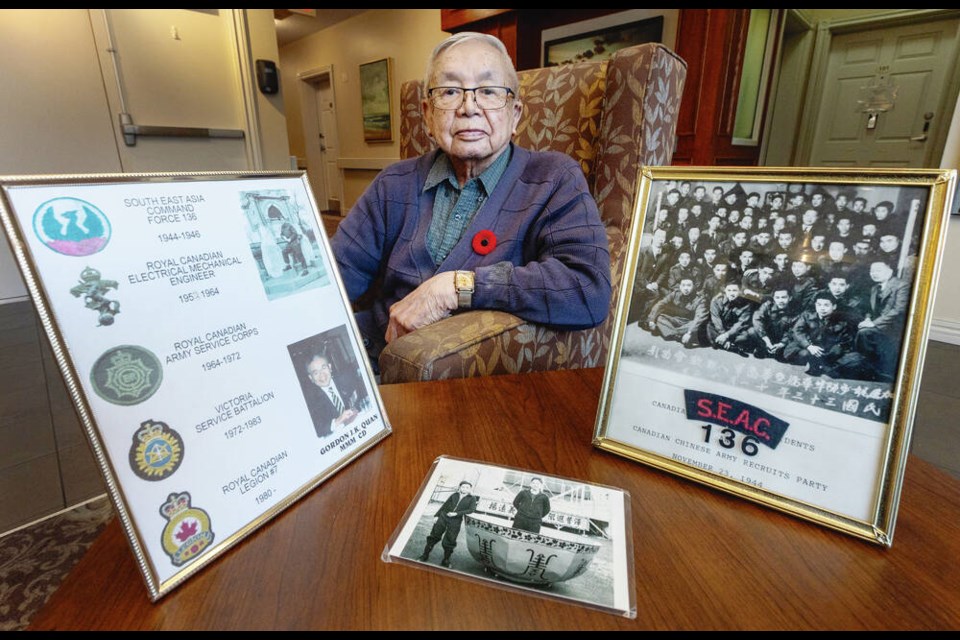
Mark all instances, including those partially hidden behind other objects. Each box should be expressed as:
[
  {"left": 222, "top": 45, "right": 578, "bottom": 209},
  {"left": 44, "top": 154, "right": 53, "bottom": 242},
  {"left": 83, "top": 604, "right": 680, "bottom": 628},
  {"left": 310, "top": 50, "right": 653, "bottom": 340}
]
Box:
[{"left": 33, "top": 198, "right": 110, "bottom": 256}]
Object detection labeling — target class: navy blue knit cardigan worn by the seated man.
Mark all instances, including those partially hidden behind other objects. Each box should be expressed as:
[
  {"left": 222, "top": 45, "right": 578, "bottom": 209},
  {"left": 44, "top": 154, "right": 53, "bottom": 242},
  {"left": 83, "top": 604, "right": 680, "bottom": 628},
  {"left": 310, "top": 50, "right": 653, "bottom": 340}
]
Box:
[{"left": 331, "top": 146, "right": 610, "bottom": 338}]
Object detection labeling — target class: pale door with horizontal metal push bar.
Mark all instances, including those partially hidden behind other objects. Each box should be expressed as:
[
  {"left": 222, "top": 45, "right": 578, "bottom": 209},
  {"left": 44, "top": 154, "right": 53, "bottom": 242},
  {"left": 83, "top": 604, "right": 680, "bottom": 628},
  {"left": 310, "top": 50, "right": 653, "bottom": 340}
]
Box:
[{"left": 89, "top": 9, "right": 254, "bottom": 173}]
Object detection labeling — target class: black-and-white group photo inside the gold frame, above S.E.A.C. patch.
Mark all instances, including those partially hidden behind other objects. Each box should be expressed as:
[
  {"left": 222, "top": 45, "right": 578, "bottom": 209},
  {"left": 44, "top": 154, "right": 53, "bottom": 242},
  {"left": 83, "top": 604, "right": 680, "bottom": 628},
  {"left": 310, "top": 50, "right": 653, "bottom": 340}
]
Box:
[{"left": 623, "top": 180, "right": 927, "bottom": 420}]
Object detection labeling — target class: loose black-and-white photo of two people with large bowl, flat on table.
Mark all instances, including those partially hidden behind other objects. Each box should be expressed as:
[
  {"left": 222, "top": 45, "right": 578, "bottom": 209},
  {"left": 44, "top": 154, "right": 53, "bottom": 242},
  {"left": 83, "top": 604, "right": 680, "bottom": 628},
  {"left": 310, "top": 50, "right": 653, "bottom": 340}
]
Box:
[{"left": 382, "top": 456, "right": 637, "bottom": 618}]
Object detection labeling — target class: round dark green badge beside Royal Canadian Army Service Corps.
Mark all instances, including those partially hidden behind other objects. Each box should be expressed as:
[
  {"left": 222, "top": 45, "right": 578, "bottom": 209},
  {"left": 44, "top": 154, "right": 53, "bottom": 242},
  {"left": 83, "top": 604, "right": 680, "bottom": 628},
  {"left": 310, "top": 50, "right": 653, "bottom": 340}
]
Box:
[{"left": 90, "top": 345, "right": 163, "bottom": 405}]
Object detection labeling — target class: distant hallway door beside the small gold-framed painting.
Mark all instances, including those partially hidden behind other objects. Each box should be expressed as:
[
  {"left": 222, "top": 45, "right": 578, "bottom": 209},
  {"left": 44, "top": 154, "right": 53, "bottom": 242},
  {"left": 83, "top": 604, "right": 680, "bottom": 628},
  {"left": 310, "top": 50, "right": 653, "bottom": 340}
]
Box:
[{"left": 301, "top": 67, "right": 342, "bottom": 213}]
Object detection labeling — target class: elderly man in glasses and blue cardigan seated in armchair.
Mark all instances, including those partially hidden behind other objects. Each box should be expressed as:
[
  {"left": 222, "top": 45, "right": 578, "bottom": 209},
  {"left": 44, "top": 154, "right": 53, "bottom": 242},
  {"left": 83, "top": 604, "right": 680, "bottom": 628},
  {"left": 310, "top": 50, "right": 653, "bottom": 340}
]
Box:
[{"left": 331, "top": 32, "right": 610, "bottom": 366}]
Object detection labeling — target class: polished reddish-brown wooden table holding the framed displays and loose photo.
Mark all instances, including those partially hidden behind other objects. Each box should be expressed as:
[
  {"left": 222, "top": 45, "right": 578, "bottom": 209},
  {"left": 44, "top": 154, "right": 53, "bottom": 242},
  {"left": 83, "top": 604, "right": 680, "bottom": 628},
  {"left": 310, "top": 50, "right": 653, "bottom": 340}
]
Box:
[{"left": 31, "top": 369, "right": 960, "bottom": 630}]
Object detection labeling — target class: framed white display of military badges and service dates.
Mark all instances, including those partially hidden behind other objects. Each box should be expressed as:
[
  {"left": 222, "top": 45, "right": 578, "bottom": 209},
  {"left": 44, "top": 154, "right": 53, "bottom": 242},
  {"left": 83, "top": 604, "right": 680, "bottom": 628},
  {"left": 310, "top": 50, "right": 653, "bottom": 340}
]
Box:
[{"left": 0, "top": 172, "right": 391, "bottom": 600}]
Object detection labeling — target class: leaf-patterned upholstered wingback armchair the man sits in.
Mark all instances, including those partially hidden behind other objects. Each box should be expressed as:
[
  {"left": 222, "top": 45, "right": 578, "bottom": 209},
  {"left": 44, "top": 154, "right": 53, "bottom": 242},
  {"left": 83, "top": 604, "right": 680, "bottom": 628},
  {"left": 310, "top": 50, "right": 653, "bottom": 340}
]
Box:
[{"left": 380, "top": 44, "right": 687, "bottom": 384}]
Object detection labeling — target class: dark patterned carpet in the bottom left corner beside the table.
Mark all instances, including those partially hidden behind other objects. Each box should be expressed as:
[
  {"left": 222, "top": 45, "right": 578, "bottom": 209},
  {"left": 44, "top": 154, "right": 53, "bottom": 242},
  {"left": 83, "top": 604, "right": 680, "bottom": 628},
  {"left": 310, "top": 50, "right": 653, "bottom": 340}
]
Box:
[{"left": 0, "top": 496, "right": 114, "bottom": 631}]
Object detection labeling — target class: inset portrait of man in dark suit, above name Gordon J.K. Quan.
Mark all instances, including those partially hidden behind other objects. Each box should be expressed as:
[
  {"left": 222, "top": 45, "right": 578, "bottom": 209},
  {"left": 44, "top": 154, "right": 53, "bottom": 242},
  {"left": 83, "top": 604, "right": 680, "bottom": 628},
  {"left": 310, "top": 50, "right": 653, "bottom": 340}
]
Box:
[{"left": 287, "top": 325, "right": 372, "bottom": 438}]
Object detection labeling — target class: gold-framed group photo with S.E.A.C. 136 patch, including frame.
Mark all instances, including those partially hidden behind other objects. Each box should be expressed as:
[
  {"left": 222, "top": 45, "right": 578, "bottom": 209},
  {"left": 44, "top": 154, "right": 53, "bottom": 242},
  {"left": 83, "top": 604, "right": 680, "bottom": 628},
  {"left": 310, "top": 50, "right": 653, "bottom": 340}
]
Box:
[{"left": 594, "top": 167, "right": 956, "bottom": 546}]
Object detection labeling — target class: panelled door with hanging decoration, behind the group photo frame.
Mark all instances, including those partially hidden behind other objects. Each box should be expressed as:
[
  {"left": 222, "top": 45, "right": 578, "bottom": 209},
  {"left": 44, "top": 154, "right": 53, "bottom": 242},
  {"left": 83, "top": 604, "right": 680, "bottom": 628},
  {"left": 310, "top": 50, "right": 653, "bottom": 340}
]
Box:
[{"left": 809, "top": 18, "right": 960, "bottom": 168}]
